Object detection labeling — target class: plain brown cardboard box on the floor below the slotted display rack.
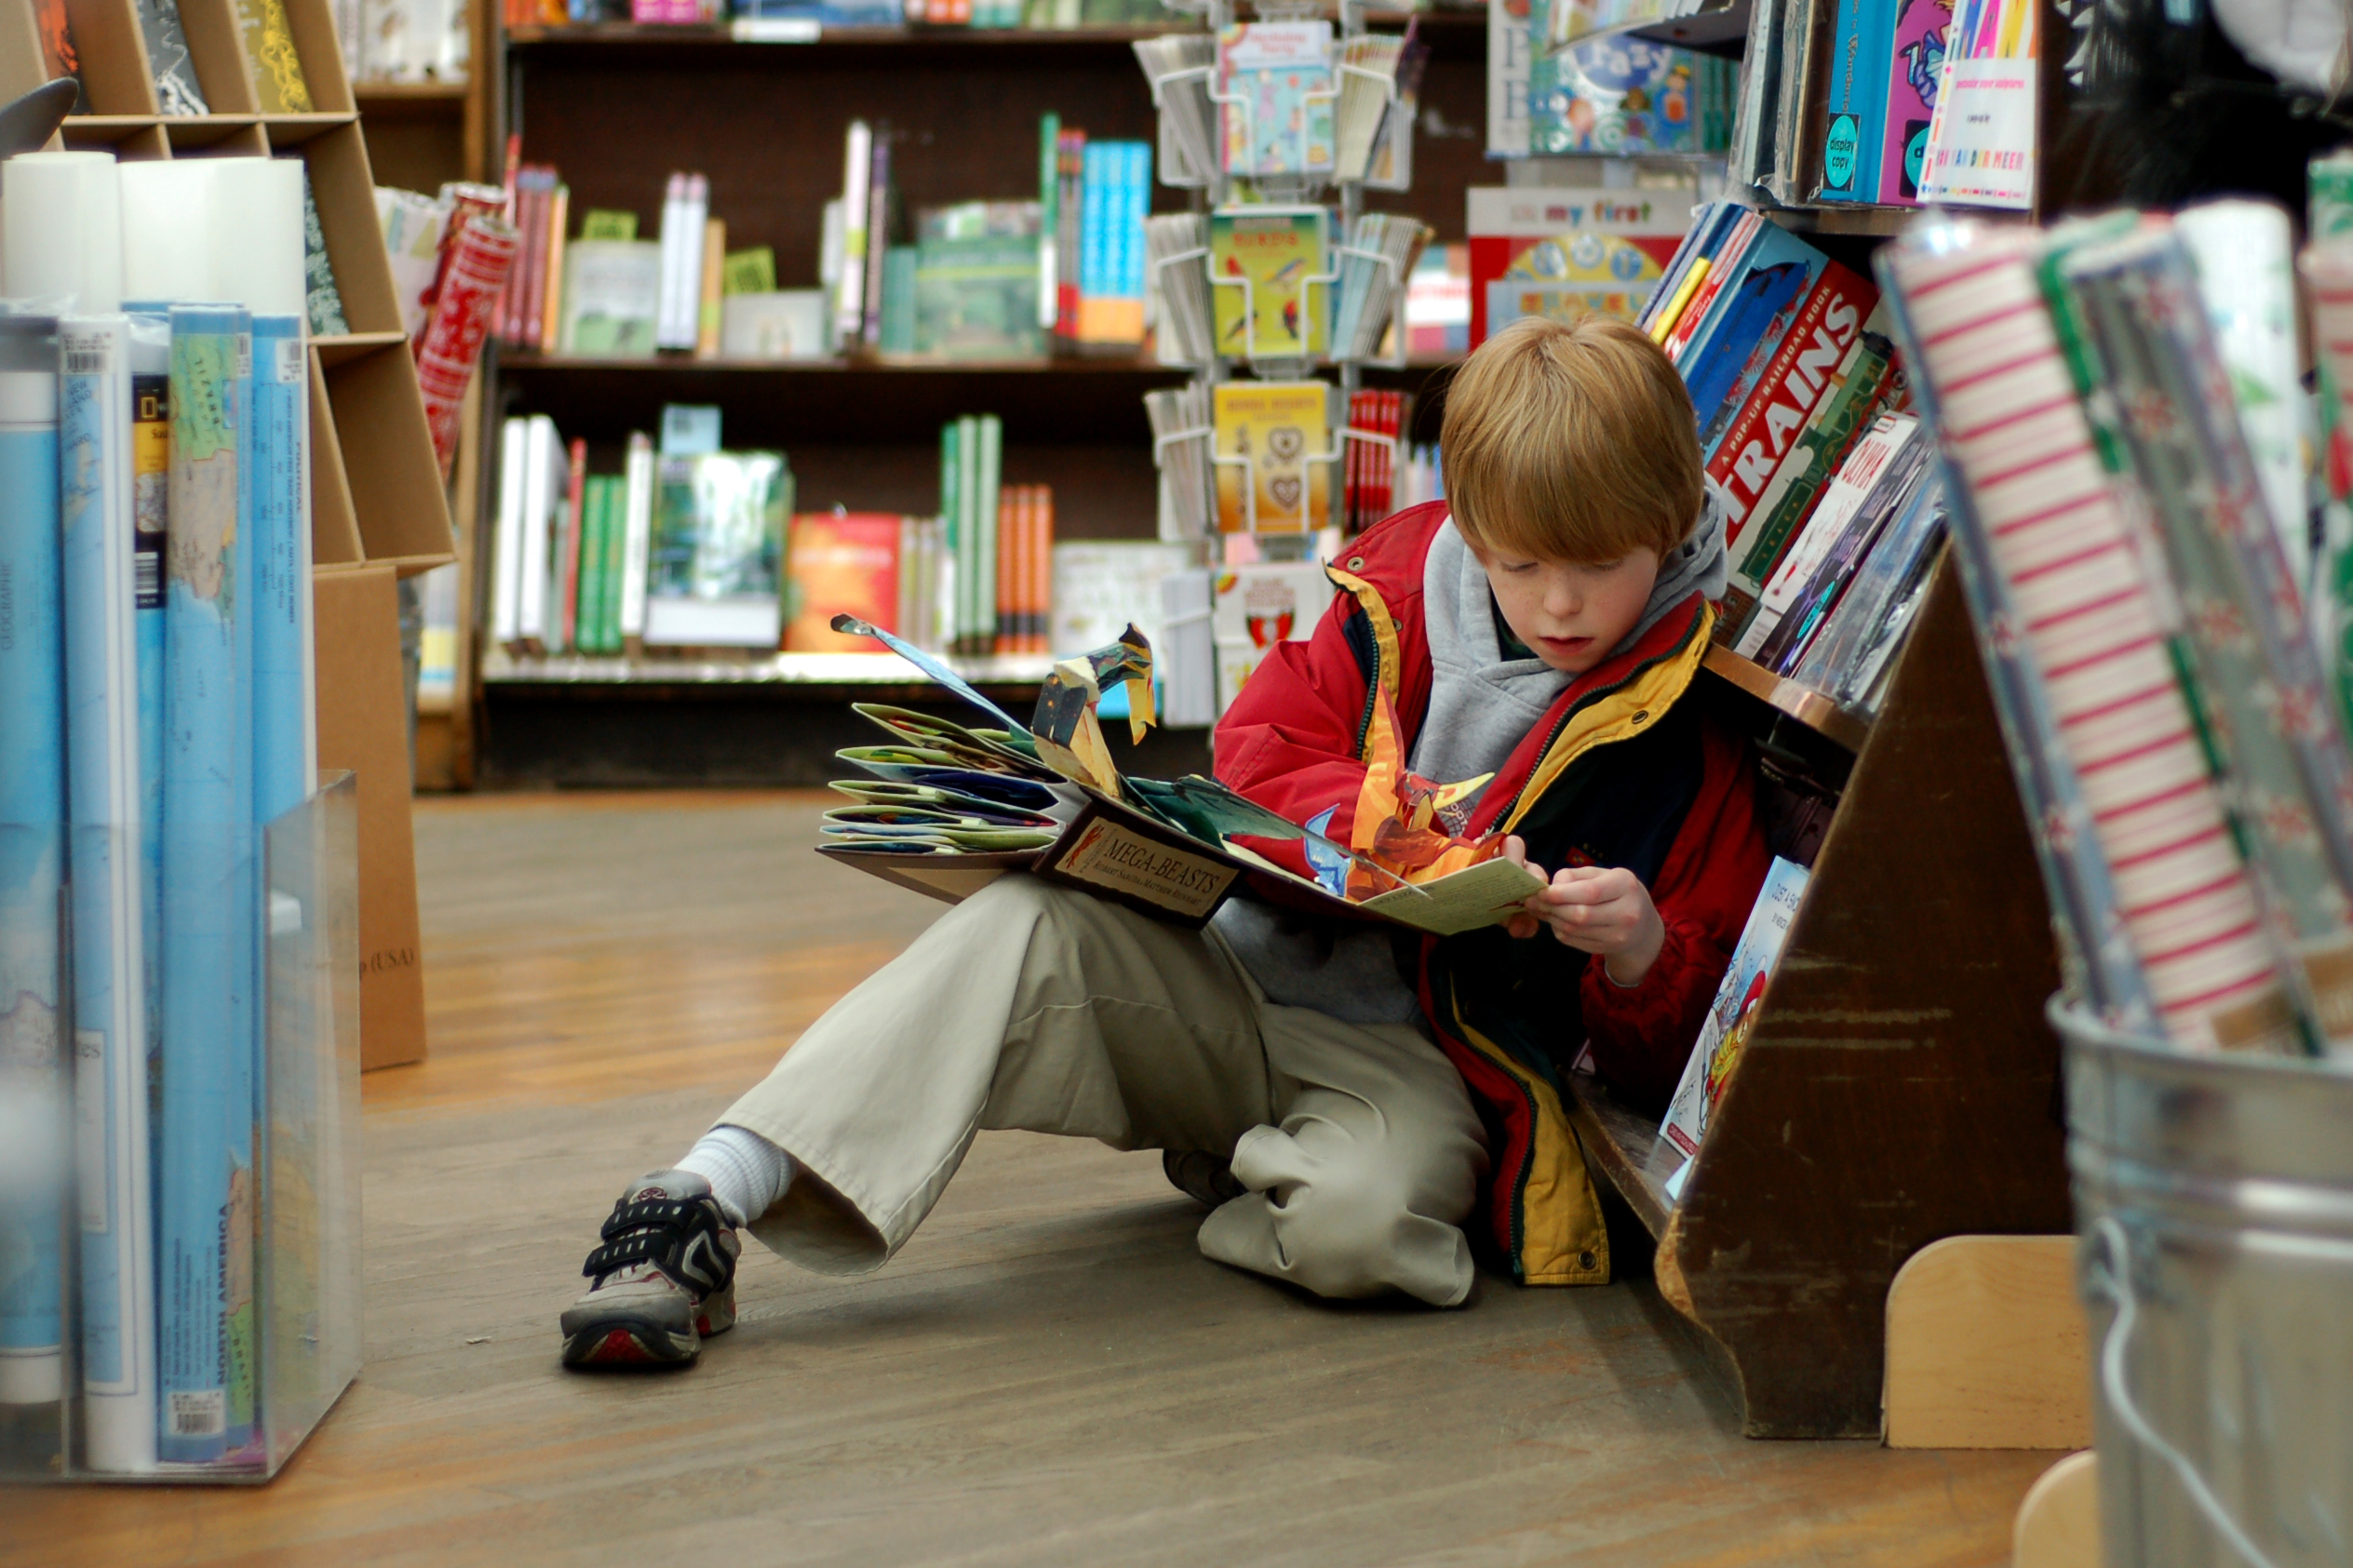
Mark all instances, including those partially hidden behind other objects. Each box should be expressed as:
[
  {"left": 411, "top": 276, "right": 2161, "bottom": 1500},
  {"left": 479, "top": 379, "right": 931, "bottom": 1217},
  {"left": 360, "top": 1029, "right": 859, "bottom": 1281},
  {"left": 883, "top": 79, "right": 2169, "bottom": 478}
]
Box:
[{"left": 313, "top": 564, "right": 426, "bottom": 1072}]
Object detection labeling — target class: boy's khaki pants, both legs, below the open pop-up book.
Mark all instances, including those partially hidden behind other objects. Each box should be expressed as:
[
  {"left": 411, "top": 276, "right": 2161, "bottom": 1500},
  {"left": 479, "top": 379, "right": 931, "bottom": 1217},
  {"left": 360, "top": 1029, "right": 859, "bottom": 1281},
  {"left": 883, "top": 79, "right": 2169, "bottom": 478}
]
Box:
[{"left": 720, "top": 877, "right": 1487, "bottom": 1307}]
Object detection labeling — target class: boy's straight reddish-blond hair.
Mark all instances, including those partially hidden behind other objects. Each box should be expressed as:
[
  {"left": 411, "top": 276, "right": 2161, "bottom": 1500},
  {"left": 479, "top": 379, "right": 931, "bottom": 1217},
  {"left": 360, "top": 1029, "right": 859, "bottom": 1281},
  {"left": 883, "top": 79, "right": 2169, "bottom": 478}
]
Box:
[{"left": 1438, "top": 315, "right": 1706, "bottom": 562}]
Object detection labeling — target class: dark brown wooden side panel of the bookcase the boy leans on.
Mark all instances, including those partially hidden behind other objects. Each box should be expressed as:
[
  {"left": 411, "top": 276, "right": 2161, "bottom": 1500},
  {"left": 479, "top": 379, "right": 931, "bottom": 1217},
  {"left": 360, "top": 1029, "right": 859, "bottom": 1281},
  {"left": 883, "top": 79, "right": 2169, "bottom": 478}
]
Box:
[{"left": 1657, "top": 550, "right": 2071, "bottom": 1437}]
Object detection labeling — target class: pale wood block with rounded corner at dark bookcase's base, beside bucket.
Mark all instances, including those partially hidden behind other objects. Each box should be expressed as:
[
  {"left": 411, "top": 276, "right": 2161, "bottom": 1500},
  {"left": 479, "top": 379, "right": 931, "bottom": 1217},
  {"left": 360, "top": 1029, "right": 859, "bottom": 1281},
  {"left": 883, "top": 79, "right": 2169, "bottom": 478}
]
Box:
[{"left": 1887, "top": 1237, "right": 2091, "bottom": 1448}]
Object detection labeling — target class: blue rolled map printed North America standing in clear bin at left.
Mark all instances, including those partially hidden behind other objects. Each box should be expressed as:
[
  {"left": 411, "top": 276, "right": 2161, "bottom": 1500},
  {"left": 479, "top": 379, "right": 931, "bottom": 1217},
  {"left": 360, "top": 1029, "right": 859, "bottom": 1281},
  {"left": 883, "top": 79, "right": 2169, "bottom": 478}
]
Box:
[{"left": 155, "top": 305, "right": 259, "bottom": 1465}]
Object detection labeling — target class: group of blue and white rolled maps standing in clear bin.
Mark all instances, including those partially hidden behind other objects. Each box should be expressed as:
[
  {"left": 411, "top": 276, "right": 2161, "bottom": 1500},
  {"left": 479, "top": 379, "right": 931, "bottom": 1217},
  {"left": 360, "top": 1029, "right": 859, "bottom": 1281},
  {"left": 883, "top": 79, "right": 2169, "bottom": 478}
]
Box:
[{"left": 0, "top": 153, "right": 333, "bottom": 1471}]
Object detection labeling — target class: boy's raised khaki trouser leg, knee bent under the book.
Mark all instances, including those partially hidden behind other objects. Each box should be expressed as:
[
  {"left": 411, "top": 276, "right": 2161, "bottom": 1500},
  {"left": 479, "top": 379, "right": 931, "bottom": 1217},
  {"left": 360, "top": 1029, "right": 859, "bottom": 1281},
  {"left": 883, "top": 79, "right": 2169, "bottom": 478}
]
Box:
[{"left": 687, "top": 877, "right": 1275, "bottom": 1274}]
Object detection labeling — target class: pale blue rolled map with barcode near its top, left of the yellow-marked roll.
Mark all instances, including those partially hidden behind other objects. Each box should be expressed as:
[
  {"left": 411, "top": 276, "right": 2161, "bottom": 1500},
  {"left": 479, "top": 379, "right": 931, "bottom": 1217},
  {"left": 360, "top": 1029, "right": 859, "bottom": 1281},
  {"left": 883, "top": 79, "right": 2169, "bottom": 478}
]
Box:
[{"left": 59, "top": 315, "right": 155, "bottom": 1474}]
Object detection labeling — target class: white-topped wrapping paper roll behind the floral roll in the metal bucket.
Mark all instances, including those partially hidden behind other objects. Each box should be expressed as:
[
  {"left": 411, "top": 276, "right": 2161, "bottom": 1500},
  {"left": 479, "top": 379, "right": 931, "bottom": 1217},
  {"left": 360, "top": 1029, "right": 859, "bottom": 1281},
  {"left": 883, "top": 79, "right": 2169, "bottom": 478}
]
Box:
[{"left": 2174, "top": 202, "right": 2313, "bottom": 593}]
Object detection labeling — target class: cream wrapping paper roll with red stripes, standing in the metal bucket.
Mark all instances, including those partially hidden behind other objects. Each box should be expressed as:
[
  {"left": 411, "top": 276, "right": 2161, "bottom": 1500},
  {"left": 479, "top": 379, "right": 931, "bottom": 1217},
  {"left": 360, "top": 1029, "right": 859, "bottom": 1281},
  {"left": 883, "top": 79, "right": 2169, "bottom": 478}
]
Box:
[{"left": 1882, "top": 223, "right": 2296, "bottom": 1051}]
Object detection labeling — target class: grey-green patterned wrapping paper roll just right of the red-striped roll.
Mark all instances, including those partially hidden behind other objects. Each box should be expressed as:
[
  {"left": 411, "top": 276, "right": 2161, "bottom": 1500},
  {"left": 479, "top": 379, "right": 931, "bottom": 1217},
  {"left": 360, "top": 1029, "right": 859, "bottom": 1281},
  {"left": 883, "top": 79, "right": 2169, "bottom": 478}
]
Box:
[{"left": 2045, "top": 226, "right": 2353, "bottom": 1051}]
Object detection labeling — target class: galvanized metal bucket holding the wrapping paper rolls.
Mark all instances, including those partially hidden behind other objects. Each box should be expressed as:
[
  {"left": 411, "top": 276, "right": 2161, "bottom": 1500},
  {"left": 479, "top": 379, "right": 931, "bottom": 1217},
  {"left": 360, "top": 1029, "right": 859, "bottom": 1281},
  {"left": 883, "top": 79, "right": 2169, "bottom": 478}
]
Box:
[{"left": 2050, "top": 997, "right": 2353, "bottom": 1568}]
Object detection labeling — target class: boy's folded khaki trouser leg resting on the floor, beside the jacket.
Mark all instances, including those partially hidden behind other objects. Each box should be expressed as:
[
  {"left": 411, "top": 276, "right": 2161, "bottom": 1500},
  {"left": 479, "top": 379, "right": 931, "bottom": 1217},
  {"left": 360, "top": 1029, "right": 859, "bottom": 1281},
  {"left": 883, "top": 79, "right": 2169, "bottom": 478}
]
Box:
[{"left": 1200, "top": 1004, "right": 1487, "bottom": 1307}]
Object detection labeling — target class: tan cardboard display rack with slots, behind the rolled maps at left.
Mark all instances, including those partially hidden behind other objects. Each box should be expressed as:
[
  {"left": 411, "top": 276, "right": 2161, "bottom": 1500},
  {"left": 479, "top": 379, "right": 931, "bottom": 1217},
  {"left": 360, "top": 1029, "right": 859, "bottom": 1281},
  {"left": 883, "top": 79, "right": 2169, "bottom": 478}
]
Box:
[{"left": 0, "top": 0, "right": 456, "bottom": 1067}]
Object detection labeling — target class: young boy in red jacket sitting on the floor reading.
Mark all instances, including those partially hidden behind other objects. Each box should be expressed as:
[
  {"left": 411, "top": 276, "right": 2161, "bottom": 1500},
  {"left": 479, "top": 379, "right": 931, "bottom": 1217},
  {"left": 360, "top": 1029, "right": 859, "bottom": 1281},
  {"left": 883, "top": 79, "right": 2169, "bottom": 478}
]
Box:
[{"left": 562, "top": 317, "right": 1769, "bottom": 1366}]
